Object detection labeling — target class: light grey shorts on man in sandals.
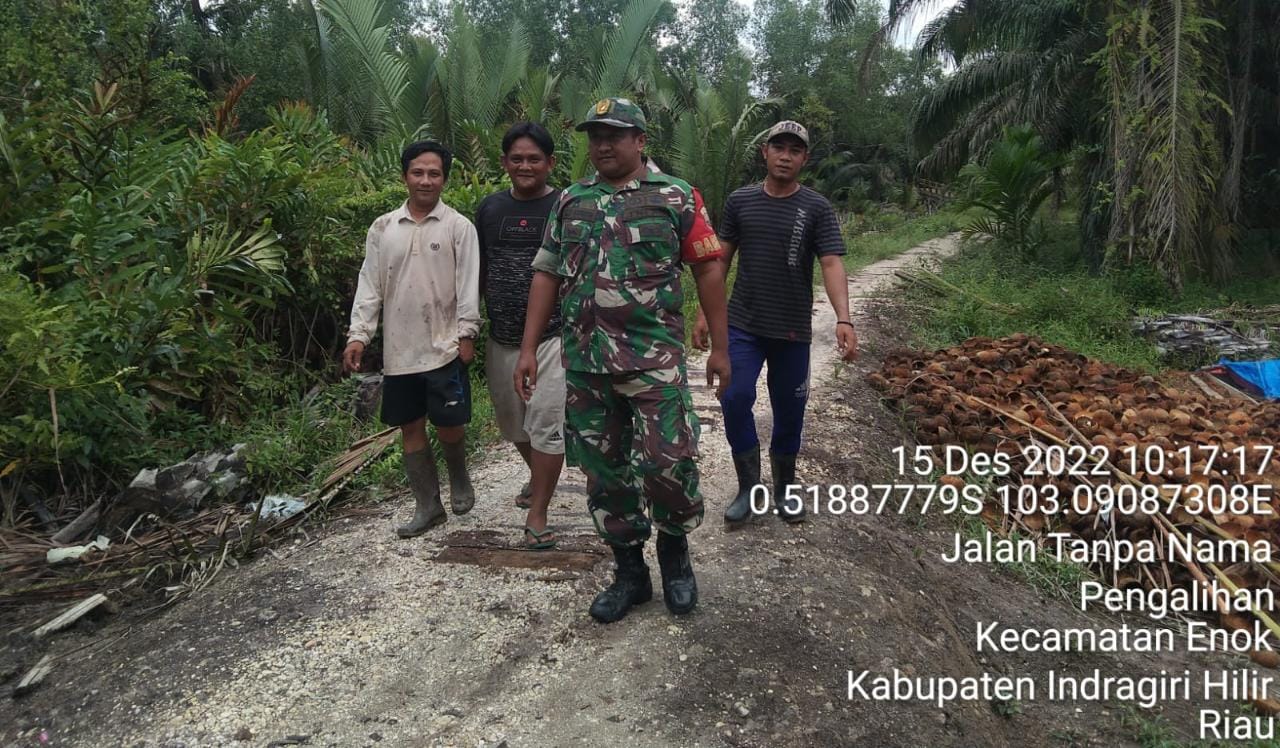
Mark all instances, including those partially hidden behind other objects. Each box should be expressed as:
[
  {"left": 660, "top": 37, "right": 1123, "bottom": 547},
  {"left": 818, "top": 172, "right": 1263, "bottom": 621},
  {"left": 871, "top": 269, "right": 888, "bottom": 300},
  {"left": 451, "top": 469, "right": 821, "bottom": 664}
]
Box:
[{"left": 484, "top": 336, "right": 564, "bottom": 455}]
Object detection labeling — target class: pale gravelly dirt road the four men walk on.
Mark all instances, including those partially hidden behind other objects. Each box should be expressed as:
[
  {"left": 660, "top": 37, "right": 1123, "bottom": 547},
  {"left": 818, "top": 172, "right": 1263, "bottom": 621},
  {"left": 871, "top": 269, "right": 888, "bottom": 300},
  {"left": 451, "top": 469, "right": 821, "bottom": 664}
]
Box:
[{"left": 0, "top": 238, "right": 1228, "bottom": 747}]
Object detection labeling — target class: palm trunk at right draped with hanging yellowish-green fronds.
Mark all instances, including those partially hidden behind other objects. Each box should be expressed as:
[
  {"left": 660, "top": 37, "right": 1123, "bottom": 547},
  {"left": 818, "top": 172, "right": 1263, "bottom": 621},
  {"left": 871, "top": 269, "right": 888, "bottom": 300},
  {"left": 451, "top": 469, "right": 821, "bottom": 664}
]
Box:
[{"left": 1103, "top": 0, "right": 1231, "bottom": 289}]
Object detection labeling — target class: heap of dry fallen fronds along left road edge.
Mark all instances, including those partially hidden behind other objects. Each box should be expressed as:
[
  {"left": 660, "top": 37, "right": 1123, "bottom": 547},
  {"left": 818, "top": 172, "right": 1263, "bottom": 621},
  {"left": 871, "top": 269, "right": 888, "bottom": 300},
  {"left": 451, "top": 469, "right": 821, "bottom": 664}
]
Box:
[{"left": 0, "top": 429, "right": 396, "bottom": 612}]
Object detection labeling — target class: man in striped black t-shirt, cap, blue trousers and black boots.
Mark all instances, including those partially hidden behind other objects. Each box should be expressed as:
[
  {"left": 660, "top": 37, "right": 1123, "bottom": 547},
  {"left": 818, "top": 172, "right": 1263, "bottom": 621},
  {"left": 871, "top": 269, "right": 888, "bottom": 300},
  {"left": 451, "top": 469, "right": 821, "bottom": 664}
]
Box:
[{"left": 694, "top": 120, "right": 858, "bottom": 524}]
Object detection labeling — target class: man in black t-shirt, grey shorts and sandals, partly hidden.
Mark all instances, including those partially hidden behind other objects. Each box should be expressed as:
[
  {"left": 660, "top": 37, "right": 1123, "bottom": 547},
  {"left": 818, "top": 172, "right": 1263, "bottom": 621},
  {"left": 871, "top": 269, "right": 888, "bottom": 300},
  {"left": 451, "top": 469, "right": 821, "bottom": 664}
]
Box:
[{"left": 475, "top": 122, "right": 564, "bottom": 549}]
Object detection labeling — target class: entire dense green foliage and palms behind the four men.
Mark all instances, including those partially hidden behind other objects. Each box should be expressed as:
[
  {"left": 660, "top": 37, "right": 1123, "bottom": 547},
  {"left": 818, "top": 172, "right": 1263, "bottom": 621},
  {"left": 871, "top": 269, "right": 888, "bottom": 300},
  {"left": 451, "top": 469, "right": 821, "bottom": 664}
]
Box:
[{"left": 0, "top": 0, "right": 1280, "bottom": 514}]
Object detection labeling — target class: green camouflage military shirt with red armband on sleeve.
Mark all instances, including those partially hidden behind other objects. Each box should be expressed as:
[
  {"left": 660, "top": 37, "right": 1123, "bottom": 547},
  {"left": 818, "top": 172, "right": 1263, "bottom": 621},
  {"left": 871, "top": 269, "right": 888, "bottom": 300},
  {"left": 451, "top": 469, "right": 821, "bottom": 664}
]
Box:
[{"left": 534, "top": 163, "right": 722, "bottom": 374}]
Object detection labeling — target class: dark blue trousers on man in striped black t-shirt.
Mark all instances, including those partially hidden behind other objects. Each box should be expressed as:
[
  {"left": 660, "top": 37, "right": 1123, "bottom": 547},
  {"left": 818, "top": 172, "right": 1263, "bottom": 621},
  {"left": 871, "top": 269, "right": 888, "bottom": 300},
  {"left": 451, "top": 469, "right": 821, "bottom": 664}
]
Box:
[{"left": 721, "top": 327, "right": 809, "bottom": 455}]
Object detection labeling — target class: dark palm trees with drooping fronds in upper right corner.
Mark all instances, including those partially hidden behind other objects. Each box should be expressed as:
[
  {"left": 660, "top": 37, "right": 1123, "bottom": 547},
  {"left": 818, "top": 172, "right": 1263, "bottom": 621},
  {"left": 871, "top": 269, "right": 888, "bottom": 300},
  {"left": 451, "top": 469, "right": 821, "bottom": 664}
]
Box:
[{"left": 882, "top": 0, "right": 1280, "bottom": 291}]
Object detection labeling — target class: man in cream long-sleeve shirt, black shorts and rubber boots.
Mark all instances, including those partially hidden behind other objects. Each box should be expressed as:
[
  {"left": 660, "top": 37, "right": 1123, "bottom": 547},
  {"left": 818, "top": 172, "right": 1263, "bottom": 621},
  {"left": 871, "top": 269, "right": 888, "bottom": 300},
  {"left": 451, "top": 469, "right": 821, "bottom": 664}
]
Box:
[{"left": 343, "top": 141, "right": 480, "bottom": 538}]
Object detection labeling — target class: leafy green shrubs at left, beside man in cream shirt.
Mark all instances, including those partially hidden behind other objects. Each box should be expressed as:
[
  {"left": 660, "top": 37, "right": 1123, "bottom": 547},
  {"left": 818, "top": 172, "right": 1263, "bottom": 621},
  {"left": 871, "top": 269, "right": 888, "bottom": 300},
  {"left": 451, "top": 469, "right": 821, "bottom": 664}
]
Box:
[{"left": 0, "top": 86, "right": 497, "bottom": 496}]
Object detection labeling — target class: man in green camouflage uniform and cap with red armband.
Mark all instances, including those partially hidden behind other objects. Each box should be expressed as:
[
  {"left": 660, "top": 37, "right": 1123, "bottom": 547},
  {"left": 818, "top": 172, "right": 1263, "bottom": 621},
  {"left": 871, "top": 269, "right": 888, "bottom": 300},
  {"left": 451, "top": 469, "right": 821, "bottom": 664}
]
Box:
[{"left": 513, "top": 99, "right": 728, "bottom": 622}]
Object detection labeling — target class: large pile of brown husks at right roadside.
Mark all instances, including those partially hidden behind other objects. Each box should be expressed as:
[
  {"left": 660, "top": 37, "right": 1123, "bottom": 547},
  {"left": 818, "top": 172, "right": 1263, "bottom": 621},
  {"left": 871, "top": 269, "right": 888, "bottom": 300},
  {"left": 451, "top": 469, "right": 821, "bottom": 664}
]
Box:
[{"left": 868, "top": 334, "right": 1280, "bottom": 655}]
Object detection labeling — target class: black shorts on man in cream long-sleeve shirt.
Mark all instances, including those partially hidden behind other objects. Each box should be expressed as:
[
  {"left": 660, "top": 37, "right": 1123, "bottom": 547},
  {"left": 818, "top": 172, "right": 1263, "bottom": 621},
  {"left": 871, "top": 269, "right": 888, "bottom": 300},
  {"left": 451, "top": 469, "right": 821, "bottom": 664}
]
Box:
[{"left": 383, "top": 359, "right": 471, "bottom": 428}]
